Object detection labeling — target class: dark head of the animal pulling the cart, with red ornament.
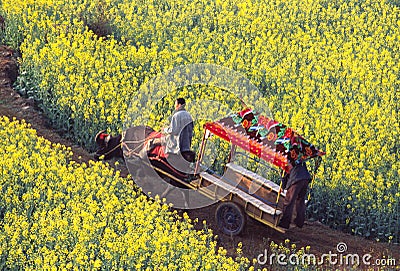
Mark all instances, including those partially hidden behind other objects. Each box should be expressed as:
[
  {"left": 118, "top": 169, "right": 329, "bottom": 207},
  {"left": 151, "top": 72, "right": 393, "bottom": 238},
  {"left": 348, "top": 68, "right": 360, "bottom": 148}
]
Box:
[{"left": 94, "top": 130, "right": 123, "bottom": 161}]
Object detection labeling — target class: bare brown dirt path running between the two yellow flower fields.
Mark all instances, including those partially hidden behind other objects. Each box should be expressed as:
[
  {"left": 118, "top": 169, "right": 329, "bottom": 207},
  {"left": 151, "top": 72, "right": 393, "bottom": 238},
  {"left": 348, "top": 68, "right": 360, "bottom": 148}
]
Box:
[{"left": 0, "top": 46, "right": 400, "bottom": 270}]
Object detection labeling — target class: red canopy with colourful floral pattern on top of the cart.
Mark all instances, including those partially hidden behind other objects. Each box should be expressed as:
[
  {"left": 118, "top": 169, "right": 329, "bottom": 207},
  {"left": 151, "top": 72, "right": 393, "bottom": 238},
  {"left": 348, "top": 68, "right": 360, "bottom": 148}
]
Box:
[{"left": 205, "top": 109, "right": 325, "bottom": 172}]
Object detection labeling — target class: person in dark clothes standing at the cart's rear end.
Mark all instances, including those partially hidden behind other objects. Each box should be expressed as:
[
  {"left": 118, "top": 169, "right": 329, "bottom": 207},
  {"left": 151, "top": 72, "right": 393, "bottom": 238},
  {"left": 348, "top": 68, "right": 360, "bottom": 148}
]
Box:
[{"left": 278, "top": 161, "right": 311, "bottom": 229}]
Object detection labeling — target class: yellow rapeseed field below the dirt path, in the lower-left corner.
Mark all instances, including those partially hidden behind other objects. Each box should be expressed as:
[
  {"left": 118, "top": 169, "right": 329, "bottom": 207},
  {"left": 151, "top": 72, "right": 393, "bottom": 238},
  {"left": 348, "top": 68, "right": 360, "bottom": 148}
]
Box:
[{"left": 0, "top": 117, "right": 249, "bottom": 270}]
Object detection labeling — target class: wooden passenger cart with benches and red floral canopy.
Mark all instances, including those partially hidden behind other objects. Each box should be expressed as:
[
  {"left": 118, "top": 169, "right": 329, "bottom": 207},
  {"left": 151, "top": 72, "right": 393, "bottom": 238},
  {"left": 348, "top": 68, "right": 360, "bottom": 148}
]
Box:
[{"left": 122, "top": 109, "right": 325, "bottom": 235}]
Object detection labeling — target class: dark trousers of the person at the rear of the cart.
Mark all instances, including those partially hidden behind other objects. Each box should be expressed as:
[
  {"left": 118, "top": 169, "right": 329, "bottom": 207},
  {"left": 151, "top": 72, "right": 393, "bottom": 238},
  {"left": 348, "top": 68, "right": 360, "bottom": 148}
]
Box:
[{"left": 279, "top": 180, "right": 309, "bottom": 228}]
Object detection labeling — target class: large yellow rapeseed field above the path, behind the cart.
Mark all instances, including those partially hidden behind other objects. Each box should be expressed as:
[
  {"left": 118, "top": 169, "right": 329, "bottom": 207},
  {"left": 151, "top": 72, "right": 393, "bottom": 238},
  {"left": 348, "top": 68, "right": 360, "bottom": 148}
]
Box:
[{"left": 0, "top": 0, "right": 400, "bottom": 242}]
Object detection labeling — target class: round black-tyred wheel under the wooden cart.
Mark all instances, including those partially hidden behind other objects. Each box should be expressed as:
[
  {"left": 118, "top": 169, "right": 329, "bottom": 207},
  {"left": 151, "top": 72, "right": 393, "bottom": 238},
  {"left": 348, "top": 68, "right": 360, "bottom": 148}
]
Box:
[{"left": 215, "top": 201, "right": 246, "bottom": 236}]
